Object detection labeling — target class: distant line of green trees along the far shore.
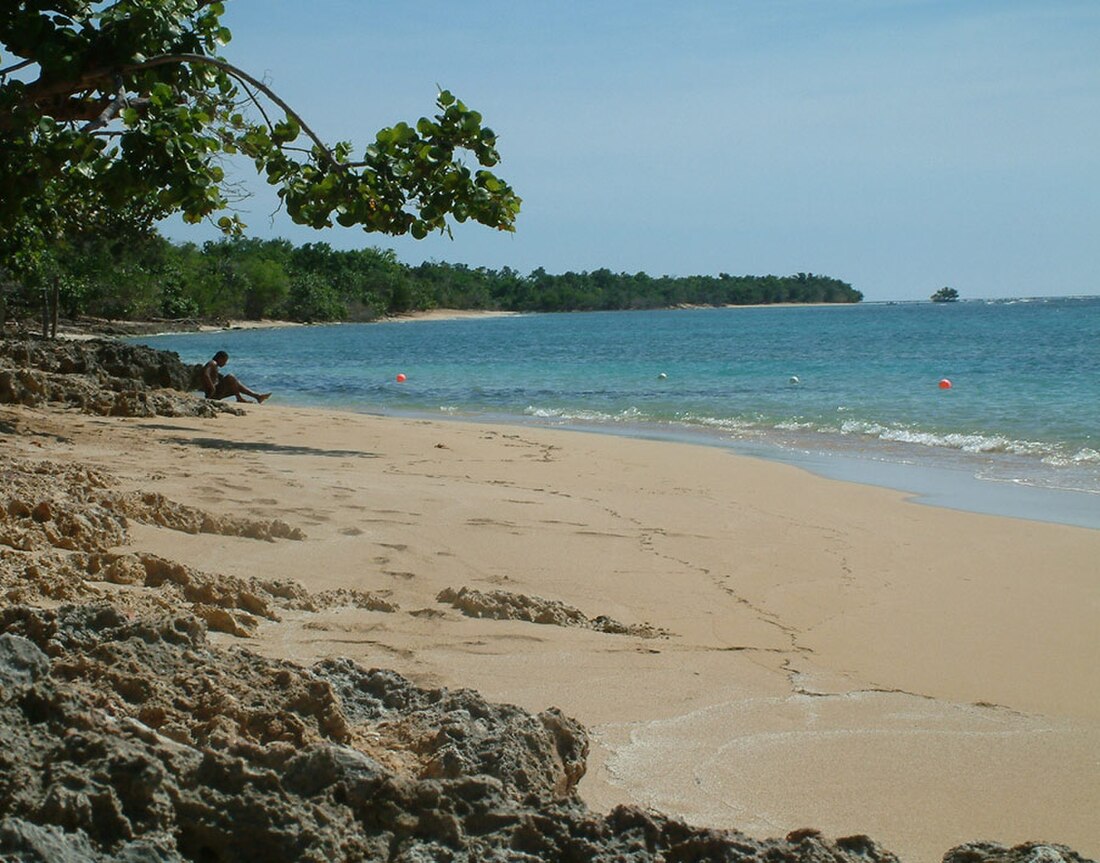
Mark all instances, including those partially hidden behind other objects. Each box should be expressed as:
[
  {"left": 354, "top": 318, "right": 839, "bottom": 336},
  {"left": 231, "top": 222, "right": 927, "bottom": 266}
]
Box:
[{"left": 0, "top": 230, "right": 862, "bottom": 321}]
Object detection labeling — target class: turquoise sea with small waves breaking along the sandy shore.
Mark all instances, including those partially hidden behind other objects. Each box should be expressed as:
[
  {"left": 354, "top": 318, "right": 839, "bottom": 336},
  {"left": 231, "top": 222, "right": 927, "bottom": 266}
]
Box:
[{"left": 134, "top": 297, "right": 1100, "bottom": 528}]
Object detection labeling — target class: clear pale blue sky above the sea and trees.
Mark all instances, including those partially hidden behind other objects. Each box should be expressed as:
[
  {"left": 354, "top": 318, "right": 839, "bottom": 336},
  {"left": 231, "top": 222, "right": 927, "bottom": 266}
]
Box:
[{"left": 162, "top": 0, "right": 1100, "bottom": 300}]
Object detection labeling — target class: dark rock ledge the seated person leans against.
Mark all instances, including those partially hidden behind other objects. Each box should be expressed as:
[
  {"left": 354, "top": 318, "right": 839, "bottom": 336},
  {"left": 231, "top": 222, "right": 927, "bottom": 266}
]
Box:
[{"left": 0, "top": 339, "right": 240, "bottom": 417}]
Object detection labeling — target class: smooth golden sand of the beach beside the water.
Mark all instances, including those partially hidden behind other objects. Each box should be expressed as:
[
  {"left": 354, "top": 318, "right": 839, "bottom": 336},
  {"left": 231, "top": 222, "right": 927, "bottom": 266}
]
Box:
[{"left": 4, "top": 402, "right": 1100, "bottom": 863}]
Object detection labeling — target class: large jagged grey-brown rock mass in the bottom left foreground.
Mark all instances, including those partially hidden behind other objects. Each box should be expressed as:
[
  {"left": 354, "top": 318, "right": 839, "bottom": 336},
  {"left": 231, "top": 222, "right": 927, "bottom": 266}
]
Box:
[{"left": 0, "top": 605, "right": 906, "bottom": 863}]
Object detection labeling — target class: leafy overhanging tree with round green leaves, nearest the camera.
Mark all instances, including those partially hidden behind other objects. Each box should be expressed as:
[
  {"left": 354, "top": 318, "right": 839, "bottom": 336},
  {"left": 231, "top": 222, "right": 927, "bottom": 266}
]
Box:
[{"left": 0, "top": 0, "right": 520, "bottom": 272}]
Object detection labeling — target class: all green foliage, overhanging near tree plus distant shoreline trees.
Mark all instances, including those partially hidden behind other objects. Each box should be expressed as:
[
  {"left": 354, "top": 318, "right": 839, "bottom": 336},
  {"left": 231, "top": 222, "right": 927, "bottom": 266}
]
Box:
[{"left": 0, "top": 0, "right": 860, "bottom": 332}]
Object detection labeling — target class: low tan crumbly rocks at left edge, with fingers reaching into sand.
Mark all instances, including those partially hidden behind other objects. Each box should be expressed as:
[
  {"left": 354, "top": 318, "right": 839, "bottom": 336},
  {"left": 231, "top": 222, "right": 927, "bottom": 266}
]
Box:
[{"left": 0, "top": 456, "right": 397, "bottom": 638}]
